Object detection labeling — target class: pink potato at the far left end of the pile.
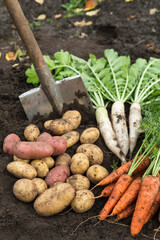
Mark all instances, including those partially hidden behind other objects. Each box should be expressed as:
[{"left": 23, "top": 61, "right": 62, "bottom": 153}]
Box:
[{"left": 3, "top": 133, "right": 21, "bottom": 156}]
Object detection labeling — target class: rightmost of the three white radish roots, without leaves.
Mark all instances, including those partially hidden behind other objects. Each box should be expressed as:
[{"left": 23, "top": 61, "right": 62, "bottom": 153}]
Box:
[{"left": 129, "top": 103, "right": 142, "bottom": 158}]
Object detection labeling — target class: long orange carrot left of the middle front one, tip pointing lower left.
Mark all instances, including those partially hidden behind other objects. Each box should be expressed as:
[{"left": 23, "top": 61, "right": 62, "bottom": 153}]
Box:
[{"left": 99, "top": 174, "right": 132, "bottom": 220}]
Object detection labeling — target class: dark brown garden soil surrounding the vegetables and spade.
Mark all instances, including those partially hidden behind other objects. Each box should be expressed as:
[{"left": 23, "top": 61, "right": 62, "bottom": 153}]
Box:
[{"left": 0, "top": 0, "right": 160, "bottom": 240}]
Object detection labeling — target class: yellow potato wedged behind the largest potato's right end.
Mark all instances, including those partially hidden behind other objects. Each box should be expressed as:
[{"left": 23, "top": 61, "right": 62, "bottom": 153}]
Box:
[{"left": 66, "top": 174, "right": 90, "bottom": 191}]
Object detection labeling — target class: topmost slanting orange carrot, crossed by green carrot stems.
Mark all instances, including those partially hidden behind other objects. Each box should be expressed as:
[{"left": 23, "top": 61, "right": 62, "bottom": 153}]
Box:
[{"left": 94, "top": 156, "right": 150, "bottom": 188}]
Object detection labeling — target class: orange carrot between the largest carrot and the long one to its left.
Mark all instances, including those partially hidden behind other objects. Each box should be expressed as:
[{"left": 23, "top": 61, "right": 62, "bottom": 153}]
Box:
[{"left": 111, "top": 178, "right": 142, "bottom": 215}]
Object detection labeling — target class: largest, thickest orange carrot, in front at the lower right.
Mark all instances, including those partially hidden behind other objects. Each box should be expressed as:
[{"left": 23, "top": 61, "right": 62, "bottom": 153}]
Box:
[{"left": 131, "top": 175, "right": 159, "bottom": 236}]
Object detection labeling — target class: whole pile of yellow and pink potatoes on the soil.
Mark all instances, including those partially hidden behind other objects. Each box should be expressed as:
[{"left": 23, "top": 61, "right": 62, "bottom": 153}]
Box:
[{"left": 3, "top": 110, "right": 108, "bottom": 216}]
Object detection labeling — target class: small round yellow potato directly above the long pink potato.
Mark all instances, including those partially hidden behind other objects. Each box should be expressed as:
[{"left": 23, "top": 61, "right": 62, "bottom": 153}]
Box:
[{"left": 24, "top": 124, "right": 40, "bottom": 142}]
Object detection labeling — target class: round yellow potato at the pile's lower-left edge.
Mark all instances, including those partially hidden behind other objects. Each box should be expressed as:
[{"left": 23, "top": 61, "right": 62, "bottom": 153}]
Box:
[{"left": 13, "top": 179, "right": 38, "bottom": 202}]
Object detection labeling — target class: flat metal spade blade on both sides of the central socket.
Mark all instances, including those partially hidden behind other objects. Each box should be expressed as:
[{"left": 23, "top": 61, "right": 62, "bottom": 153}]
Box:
[{"left": 19, "top": 75, "right": 94, "bottom": 121}]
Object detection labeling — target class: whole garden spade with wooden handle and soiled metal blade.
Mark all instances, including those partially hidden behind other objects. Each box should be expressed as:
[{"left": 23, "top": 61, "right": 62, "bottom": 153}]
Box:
[{"left": 4, "top": 0, "right": 93, "bottom": 121}]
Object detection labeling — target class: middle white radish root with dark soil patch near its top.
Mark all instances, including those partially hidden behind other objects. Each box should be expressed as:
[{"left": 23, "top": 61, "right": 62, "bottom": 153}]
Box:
[{"left": 111, "top": 101, "right": 129, "bottom": 156}]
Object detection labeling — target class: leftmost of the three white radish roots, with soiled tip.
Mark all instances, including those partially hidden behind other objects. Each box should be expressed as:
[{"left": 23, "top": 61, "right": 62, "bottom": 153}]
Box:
[{"left": 96, "top": 107, "right": 126, "bottom": 165}]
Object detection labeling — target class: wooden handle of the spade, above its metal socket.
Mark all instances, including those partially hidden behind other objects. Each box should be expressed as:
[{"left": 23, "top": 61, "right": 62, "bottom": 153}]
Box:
[{"left": 3, "top": 0, "right": 46, "bottom": 68}]
